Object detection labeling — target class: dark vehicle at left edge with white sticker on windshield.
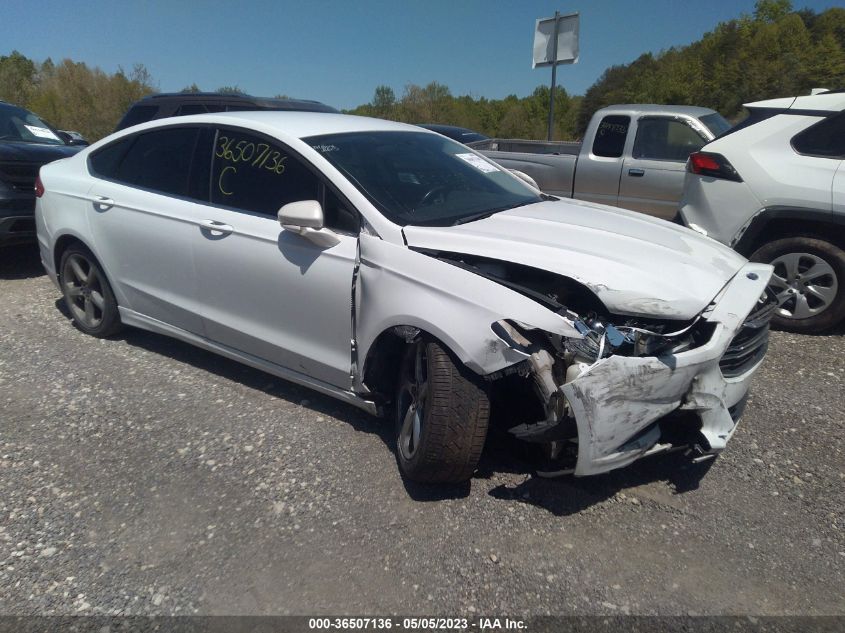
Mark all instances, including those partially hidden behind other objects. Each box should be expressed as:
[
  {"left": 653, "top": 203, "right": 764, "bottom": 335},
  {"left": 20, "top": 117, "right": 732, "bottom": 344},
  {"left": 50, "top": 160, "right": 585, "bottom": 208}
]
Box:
[{"left": 0, "top": 101, "right": 82, "bottom": 246}]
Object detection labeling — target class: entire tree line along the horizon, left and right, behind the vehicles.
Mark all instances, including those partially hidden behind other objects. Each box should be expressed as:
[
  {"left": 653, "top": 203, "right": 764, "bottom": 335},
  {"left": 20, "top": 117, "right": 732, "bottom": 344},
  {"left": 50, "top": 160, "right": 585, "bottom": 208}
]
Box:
[{"left": 0, "top": 0, "right": 845, "bottom": 141}]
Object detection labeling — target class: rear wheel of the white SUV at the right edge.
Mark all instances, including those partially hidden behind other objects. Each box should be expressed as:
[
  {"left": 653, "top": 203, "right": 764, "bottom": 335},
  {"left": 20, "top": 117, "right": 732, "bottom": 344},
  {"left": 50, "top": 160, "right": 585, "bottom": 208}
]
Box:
[{"left": 750, "top": 237, "right": 845, "bottom": 333}]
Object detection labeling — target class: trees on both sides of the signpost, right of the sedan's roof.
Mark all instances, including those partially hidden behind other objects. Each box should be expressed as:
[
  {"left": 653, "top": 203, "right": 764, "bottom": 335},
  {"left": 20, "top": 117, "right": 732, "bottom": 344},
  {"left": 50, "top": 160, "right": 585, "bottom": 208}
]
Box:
[{"left": 352, "top": 0, "right": 845, "bottom": 140}]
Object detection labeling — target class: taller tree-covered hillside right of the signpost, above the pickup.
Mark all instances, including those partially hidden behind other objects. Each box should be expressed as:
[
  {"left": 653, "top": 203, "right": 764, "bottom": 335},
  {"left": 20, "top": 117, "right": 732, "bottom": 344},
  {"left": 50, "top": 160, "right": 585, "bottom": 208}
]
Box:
[{"left": 577, "top": 0, "right": 845, "bottom": 132}]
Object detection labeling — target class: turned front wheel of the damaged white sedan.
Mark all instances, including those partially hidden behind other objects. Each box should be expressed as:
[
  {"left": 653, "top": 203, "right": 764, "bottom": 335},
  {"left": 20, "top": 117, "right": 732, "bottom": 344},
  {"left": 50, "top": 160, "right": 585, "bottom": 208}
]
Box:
[{"left": 396, "top": 338, "right": 490, "bottom": 483}]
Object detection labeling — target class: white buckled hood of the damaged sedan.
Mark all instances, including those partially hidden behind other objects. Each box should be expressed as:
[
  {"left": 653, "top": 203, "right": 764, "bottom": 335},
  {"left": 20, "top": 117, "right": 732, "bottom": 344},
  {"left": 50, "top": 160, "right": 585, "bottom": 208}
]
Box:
[{"left": 404, "top": 200, "right": 746, "bottom": 320}]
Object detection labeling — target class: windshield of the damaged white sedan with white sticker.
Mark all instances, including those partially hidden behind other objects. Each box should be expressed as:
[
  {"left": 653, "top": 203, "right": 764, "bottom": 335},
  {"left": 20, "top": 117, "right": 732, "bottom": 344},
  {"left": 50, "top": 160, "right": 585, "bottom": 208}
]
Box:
[{"left": 303, "top": 132, "right": 542, "bottom": 226}]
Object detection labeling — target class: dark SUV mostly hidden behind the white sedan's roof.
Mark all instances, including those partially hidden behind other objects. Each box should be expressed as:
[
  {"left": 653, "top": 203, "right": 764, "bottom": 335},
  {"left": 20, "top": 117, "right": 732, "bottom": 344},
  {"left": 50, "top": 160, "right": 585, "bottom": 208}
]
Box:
[{"left": 114, "top": 92, "right": 338, "bottom": 132}]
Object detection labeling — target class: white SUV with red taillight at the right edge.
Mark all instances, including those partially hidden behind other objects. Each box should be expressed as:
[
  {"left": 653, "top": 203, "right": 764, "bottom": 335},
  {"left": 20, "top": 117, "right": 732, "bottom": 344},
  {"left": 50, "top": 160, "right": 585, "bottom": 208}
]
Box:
[{"left": 680, "top": 91, "right": 845, "bottom": 332}]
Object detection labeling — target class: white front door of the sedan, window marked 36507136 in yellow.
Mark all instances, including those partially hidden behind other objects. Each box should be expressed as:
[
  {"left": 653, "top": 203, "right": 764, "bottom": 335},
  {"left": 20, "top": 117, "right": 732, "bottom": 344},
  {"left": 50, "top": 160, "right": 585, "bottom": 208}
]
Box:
[{"left": 192, "top": 127, "right": 359, "bottom": 388}]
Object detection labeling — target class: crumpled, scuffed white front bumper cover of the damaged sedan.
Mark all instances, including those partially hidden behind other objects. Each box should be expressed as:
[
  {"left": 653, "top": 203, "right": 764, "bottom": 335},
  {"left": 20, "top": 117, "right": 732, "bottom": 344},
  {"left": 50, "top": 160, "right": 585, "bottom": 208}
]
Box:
[{"left": 560, "top": 263, "right": 772, "bottom": 476}]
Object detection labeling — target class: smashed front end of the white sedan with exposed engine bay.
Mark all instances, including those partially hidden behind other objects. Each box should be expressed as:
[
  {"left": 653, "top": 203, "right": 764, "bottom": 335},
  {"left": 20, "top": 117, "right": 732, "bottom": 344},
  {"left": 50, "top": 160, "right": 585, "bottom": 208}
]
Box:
[{"left": 446, "top": 253, "right": 774, "bottom": 476}]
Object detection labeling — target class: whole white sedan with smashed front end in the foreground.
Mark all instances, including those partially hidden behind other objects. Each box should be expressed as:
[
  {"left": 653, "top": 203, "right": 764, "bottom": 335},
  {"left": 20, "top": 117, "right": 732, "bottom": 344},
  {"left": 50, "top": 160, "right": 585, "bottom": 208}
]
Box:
[{"left": 36, "top": 112, "right": 774, "bottom": 482}]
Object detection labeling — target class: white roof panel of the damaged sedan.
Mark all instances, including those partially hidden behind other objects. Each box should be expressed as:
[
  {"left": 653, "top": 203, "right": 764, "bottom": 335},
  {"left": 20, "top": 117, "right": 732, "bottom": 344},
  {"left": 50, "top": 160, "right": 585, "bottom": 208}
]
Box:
[{"left": 121, "top": 110, "right": 433, "bottom": 139}]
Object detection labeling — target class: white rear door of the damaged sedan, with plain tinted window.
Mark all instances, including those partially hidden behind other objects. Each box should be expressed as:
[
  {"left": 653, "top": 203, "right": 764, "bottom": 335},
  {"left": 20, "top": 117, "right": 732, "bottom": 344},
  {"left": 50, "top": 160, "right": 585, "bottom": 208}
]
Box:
[{"left": 87, "top": 126, "right": 211, "bottom": 334}]
